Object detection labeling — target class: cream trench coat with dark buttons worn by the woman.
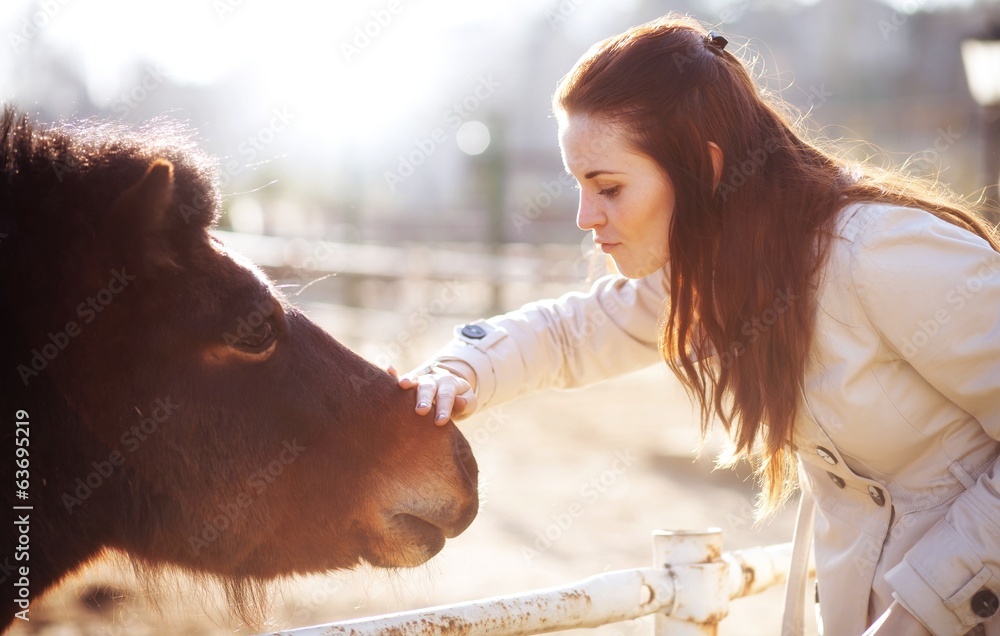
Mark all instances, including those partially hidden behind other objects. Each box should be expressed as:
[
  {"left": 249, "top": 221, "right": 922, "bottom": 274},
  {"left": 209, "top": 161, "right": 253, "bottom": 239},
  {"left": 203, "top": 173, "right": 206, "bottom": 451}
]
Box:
[{"left": 424, "top": 205, "right": 1000, "bottom": 636}]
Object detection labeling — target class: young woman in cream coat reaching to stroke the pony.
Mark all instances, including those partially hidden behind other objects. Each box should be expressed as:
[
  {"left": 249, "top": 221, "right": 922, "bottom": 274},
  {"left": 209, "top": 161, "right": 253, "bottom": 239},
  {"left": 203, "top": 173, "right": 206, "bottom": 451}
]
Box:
[{"left": 390, "top": 17, "right": 1000, "bottom": 635}]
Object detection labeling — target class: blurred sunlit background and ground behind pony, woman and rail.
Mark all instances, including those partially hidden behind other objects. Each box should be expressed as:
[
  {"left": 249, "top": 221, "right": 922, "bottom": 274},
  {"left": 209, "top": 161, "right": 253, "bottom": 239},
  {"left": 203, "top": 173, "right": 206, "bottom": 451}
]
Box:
[{"left": 0, "top": 0, "right": 1000, "bottom": 634}]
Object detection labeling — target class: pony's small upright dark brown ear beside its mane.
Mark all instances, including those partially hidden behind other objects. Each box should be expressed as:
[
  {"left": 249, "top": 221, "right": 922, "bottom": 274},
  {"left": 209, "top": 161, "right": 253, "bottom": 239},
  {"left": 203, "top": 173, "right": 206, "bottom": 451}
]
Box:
[{"left": 109, "top": 159, "right": 176, "bottom": 268}]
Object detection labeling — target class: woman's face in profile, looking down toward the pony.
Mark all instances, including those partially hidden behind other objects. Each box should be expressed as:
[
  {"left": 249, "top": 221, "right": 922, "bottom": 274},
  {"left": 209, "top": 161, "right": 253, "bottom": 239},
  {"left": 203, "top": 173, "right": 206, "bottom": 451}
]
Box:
[{"left": 559, "top": 114, "right": 675, "bottom": 278}]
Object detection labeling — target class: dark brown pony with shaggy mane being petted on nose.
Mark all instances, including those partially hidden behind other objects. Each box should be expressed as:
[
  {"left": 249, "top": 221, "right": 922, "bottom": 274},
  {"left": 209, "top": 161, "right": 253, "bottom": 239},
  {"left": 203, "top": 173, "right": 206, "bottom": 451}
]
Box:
[{"left": 0, "top": 107, "right": 478, "bottom": 629}]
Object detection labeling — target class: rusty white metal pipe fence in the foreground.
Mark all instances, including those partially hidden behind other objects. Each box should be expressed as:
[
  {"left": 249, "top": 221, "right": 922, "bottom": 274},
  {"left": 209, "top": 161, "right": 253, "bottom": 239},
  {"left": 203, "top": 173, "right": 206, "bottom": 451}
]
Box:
[{"left": 260, "top": 528, "right": 812, "bottom": 636}]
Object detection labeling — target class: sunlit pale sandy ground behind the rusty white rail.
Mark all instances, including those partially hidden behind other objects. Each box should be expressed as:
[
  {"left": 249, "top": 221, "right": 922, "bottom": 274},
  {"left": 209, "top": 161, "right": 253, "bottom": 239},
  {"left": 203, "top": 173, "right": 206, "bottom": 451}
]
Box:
[{"left": 9, "top": 320, "right": 820, "bottom": 636}]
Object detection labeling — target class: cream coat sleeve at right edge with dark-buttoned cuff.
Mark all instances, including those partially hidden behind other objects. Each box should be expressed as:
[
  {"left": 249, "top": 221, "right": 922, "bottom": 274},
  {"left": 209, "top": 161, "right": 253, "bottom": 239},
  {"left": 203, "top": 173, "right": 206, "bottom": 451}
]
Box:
[{"left": 852, "top": 208, "right": 1000, "bottom": 634}]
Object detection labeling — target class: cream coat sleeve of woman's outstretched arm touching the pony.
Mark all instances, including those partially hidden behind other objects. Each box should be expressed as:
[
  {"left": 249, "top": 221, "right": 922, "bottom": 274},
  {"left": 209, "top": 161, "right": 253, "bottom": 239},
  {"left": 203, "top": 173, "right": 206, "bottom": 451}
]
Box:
[{"left": 421, "top": 268, "right": 669, "bottom": 408}]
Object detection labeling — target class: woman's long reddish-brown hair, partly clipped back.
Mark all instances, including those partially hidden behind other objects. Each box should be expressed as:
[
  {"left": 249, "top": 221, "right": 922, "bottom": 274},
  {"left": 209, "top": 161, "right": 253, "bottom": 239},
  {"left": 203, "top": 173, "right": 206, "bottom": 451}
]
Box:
[{"left": 553, "top": 15, "right": 1000, "bottom": 512}]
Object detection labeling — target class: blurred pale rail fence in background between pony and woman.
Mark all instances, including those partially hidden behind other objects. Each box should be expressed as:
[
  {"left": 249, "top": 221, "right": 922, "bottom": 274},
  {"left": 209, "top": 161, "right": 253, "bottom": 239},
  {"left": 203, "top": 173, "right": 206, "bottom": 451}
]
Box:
[{"left": 214, "top": 230, "right": 603, "bottom": 366}]
